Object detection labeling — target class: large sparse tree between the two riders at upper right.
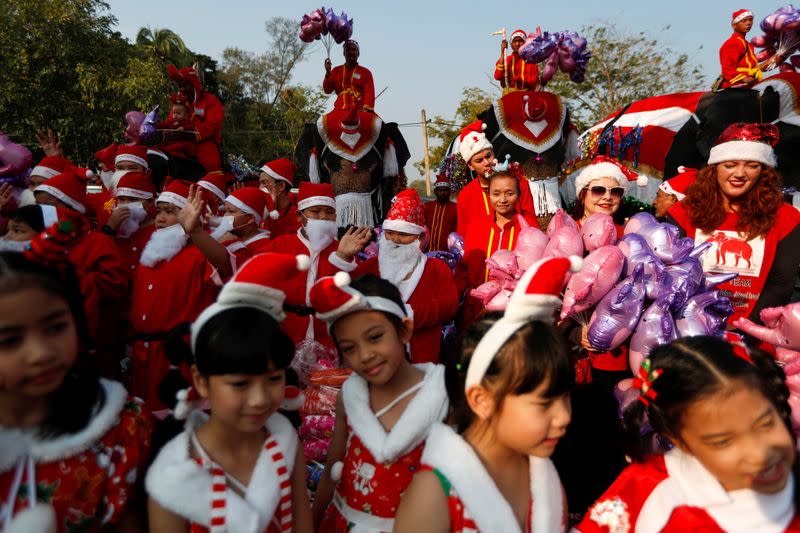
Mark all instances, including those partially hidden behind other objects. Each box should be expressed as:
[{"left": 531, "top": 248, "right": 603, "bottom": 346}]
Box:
[{"left": 546, "top": 23, "right": 707, "bottom": 130}]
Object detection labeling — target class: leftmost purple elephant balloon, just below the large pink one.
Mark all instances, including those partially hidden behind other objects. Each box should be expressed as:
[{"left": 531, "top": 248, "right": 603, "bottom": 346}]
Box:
[{"left": 588, "top": 265, "right": 645, "bottom": 351}]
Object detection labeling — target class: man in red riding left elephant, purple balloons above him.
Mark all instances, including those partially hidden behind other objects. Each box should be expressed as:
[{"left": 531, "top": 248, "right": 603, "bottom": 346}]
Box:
[{"left": 322, "top": 40, "right": 375, "bottom": 111}]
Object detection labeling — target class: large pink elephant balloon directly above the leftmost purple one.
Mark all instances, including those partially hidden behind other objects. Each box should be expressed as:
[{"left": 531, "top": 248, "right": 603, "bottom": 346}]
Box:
[{"left": 561, "top": 245, "right": 625, "bottom": 320}]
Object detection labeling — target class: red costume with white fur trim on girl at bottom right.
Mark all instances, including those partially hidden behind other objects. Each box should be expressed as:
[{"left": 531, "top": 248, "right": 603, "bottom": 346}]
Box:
[{"left": 576, "top": 449, "right": 800, "bottom": 533}]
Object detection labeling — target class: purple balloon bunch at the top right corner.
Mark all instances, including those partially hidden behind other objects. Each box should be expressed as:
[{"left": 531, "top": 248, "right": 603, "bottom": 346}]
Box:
[{"left": 750, "top": 4, "right": 800, "bottom": 72}]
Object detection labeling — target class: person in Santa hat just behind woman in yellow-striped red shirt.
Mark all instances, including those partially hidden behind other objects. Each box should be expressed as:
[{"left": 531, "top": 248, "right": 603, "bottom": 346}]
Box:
[{"left": 456, "top": 120, "right": 536, "bottom": 237}]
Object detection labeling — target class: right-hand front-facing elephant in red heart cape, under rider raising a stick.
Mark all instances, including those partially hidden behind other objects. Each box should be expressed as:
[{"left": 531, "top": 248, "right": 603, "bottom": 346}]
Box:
[{"left": 448, "top": 91, "right": 578, "bottom": 230}]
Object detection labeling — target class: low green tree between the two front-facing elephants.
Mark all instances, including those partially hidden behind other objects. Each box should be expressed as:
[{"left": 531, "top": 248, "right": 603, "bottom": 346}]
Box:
[{"left": 414, "top": 87, "right": 500, "bottom": 175}]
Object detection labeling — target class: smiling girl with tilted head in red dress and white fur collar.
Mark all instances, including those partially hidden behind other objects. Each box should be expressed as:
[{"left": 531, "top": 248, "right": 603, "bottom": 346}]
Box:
[{"left": 311, "top": 272, "right": 448, "bottom": 532}]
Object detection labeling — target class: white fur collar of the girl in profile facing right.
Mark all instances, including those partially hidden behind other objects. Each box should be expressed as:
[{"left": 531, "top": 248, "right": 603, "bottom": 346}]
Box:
[{"left": 422, "top": 424, "right": 564, "bottom": 533}]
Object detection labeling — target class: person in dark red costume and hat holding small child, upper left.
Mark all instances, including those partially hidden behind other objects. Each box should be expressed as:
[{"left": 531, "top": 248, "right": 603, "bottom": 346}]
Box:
[{"left": 167, "top": 65, "right": 225, "bottom": 172}]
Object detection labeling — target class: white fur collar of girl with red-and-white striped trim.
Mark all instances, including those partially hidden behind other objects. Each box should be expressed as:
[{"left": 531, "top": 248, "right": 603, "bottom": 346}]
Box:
[{"left": 145, "top": 411, "right": 297, "bottom": 533}]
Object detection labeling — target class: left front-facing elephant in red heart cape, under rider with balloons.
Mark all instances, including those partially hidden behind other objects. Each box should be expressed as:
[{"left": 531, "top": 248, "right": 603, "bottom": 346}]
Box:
[{"left": 294, "top": 109, "right": 411, "bottom": 227}]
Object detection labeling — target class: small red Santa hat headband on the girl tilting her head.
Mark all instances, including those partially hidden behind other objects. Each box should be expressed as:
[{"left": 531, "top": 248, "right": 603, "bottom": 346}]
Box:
[{"left": 308, "top": 272, "right": 408, "bottom": 328}]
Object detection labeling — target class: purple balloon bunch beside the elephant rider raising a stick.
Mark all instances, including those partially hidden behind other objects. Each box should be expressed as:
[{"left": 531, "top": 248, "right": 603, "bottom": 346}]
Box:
[{"left": 518, "top": 31, "right": 592, "bottom": 86}]
